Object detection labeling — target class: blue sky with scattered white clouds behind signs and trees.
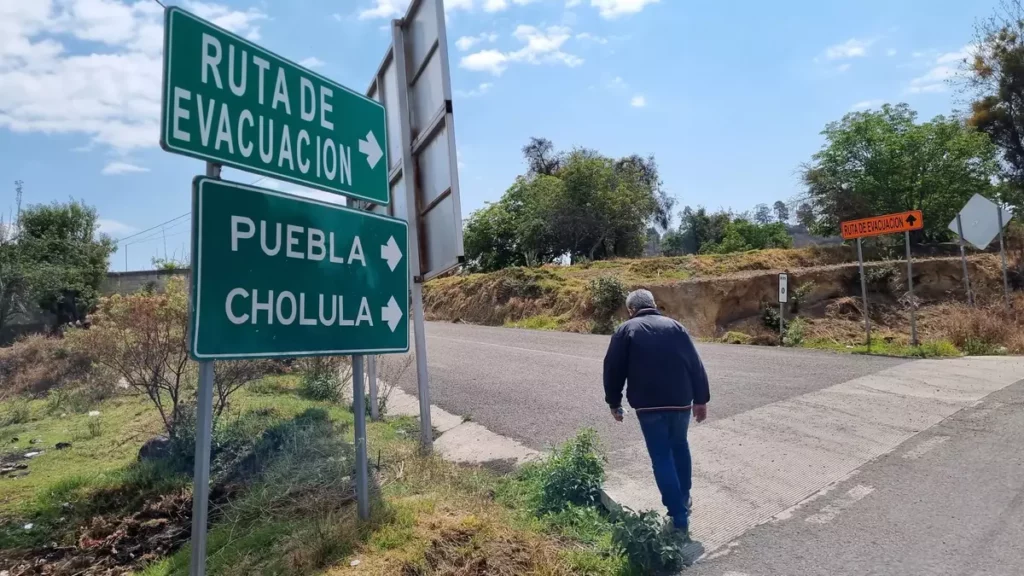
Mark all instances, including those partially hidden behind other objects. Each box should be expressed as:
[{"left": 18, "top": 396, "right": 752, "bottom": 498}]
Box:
[{"left": 0, "top": 0, "right": 996, "bottom": 270}]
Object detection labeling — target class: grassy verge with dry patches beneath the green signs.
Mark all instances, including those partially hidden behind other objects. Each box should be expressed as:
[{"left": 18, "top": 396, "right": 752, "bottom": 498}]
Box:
[{"left": 0, "top": 375, "right": 628, "bottom": 576}]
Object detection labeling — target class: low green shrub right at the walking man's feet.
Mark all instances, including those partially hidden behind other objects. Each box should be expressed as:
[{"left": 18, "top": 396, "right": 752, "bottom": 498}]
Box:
[{"left": 612, "top": 508, "right": 687, "bottom": 574}]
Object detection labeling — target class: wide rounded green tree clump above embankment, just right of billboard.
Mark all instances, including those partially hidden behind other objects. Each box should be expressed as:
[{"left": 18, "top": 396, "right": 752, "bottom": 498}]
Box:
[{"left": 464, "top": 138, "right": 673, "bottom": 271}]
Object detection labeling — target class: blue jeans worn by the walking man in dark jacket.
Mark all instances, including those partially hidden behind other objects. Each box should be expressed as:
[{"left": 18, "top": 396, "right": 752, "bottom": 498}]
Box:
[{"left": 637, "top": 410, "right": 693, "bottom": 530}]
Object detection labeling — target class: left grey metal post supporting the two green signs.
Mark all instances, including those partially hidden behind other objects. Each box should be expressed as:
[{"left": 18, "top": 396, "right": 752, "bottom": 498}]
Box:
[{"left": 190, "top": 157, "right": 220, "bottom": 576}]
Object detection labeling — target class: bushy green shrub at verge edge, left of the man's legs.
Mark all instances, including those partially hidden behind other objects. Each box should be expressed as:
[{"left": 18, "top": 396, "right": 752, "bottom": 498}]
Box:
[{"left": 538, "top": 428, "right": 604, "bottom": 513}]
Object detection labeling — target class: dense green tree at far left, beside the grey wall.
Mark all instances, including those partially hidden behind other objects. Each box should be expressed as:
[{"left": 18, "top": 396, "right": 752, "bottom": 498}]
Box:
[{"left": 17, "top": 200, "right": 115, "bottom": 324}]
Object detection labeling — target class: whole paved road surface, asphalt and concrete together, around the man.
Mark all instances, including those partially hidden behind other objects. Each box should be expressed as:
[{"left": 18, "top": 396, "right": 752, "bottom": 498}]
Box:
[{"left": 399, "top": 323, "right": 1024, "bottom": 576}]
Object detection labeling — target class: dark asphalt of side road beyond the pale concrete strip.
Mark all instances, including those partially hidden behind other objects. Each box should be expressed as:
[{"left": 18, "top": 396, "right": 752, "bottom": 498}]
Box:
[{"left": 400, "top": 323, "right": 906, "bottom": 450}]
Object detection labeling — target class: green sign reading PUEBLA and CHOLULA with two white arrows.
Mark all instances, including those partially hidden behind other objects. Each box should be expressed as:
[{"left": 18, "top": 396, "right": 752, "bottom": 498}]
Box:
[{"left": 189, "top": 176, "right": 409, "bottom": 361}]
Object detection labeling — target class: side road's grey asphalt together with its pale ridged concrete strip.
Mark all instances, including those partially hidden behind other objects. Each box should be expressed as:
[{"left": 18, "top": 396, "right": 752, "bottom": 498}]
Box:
[{"left": 393, "top": 323, "right": 1024, "bottom": 565}]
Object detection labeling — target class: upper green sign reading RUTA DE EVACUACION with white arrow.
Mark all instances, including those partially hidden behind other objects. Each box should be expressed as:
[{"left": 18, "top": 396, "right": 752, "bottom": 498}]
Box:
[{"left": 160, "top": 6, "right": 390, "bottom": 204}]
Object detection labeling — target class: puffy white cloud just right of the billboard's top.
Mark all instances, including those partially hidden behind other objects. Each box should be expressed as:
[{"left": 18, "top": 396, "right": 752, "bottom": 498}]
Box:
[{"left": 459, "top": 25, "right": 583, "bottom": 76}]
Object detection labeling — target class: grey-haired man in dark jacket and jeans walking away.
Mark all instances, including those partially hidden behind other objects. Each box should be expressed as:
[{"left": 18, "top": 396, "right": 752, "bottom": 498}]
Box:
[{"left": 604, "top": 290, "right": 711, "bottom": 535}]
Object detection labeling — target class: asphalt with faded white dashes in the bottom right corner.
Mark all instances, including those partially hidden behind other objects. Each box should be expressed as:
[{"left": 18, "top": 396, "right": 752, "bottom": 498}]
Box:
[{"left": 687, "top": 382, "right": 1024, "bottom": 576}]
